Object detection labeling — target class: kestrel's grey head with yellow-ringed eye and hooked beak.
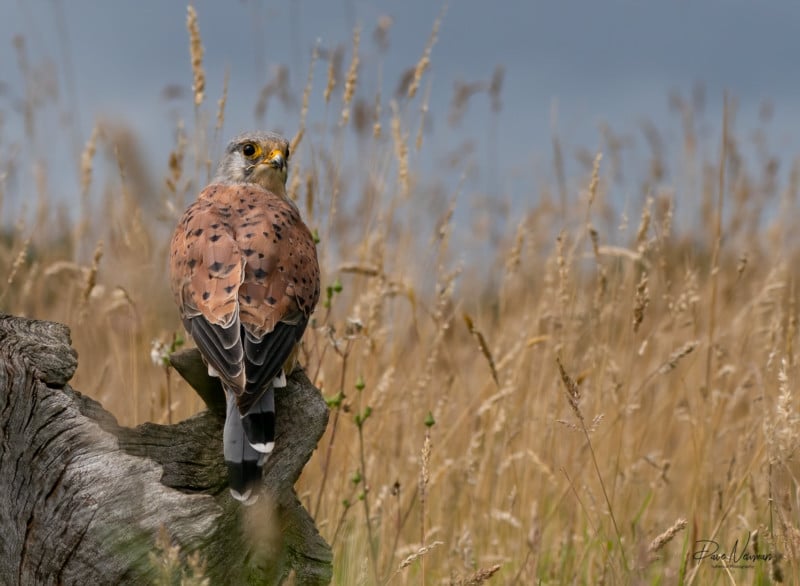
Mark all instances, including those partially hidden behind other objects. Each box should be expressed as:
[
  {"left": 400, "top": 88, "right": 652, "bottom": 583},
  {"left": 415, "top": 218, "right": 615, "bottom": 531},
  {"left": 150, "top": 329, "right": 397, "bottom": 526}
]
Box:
[{"left": 214, "top": 132, "right": 289, "bottom": 197}]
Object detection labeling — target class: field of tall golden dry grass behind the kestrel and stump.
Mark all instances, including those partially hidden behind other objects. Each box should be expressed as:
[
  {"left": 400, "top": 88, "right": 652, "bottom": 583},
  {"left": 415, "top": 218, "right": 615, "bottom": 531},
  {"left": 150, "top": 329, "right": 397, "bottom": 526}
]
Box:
[{"left": 0, "top": 5, "right": 800, "bottom": 584}]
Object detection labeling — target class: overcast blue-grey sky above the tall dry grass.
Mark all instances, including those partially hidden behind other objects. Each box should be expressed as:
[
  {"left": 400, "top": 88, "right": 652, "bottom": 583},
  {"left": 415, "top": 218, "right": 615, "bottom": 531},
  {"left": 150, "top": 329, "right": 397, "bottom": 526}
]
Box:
[{"left": 0, "top": 0, "right": 800, "bottom": 221}]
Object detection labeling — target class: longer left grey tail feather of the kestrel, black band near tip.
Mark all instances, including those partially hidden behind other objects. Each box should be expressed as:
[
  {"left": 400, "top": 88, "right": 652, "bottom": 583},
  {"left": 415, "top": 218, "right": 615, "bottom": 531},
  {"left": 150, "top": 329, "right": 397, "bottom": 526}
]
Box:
[{"left": 222, "top": 392, "right": 262, "bottom": 505}]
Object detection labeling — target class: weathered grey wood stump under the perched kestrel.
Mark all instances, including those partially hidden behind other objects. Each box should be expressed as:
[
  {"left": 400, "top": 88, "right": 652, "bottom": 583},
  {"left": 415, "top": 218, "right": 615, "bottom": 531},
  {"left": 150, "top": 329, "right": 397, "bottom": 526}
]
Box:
[{"left": 0, "top": 314, "right": 332, "bottom": 585}]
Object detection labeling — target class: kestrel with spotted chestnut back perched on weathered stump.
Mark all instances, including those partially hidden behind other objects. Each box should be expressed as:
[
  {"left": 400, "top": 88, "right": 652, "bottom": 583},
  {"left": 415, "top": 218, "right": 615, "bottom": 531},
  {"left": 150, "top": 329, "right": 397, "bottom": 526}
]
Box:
[{"left": 169, "top": 131, "right": 320, "bottom": 505}]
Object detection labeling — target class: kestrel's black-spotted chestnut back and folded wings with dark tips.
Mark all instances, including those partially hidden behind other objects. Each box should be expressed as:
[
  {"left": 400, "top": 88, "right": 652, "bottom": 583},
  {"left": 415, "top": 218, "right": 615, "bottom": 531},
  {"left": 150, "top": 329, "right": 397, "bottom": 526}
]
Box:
[{"left": 170, "top": 185, "right": 319, "bottom": 414}]
